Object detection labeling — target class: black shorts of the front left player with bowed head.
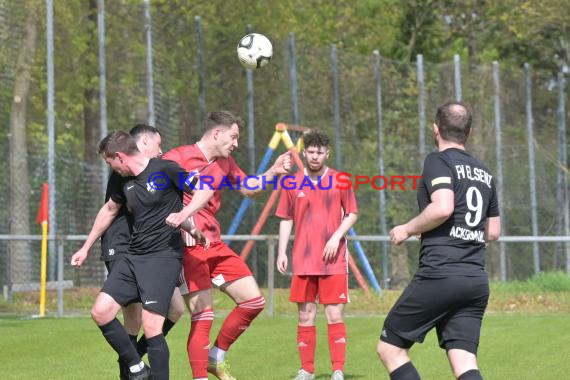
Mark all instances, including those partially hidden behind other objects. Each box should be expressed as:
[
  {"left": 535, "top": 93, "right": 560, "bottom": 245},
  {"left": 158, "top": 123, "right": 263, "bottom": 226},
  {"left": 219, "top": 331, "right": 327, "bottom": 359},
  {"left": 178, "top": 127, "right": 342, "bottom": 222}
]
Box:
[{"left": 101, "top": 254, "right": 182, "bottom": 317}]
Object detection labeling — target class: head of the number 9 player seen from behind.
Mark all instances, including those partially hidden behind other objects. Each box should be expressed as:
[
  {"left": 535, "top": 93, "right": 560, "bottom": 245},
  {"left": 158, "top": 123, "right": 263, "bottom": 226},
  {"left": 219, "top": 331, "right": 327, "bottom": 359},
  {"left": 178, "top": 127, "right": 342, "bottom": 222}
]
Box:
[{"left": 435, "top": 102, "right": 473, "bottom": 145}]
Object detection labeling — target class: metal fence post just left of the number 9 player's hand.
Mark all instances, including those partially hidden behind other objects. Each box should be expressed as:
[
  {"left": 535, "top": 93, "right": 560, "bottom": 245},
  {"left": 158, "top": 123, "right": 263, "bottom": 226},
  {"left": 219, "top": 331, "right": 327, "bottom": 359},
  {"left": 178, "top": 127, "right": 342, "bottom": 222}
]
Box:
[{"left": 373, "top": 50, "right": 390, "bottom": 289}]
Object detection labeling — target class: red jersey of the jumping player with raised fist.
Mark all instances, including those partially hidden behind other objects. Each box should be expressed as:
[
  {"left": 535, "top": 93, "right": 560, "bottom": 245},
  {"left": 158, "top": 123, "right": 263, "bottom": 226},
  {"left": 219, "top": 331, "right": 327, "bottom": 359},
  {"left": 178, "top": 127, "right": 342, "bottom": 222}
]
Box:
[{"left": 162, "top": 144, "right": 246, "bottom": 246}]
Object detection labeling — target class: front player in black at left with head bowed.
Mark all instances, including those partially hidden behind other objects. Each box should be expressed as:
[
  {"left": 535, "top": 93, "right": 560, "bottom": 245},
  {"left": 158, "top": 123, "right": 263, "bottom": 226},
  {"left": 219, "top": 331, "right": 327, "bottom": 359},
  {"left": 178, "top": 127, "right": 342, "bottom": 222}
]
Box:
[{"left": 79, "top": 131, "right": 207, "bottom": 379}]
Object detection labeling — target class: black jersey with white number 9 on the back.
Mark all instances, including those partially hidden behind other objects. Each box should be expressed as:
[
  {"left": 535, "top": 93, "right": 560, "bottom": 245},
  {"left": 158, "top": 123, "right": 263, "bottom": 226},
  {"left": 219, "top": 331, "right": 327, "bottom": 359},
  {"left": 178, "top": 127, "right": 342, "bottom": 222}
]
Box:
[{"left": 412, "top": 148, "right": 499, "bottom": 277}]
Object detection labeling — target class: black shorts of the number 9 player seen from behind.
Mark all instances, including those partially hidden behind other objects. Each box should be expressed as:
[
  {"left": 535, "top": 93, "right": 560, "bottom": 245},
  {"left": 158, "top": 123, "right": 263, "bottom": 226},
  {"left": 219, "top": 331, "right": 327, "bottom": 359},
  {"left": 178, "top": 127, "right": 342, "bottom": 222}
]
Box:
[{"left": 380, "top": 276, "right": 489, "bottom": 354}]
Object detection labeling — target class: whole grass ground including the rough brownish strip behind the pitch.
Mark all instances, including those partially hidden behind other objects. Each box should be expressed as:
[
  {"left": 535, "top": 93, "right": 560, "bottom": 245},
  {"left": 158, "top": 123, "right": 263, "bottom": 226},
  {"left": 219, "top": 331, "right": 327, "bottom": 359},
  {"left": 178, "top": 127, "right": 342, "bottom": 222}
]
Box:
[{"left": 0, "top": 273, "right": 570, "bottom": 380}]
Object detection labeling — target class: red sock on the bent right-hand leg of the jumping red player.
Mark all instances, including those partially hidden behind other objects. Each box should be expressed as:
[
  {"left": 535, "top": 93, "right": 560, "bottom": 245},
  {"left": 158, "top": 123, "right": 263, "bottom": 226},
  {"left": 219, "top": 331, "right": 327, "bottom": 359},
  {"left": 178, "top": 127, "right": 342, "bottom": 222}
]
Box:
[{"left": 214, "top": 296, "right": 265, "bottom": 351}]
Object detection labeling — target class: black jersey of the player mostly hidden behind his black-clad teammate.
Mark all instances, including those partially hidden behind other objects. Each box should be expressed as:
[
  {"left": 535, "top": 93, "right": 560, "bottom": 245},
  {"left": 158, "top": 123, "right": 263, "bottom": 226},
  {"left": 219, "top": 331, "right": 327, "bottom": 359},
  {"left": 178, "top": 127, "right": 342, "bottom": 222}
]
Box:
[{"left": 101, "top": 171, "right": 133, "bottom": 261}]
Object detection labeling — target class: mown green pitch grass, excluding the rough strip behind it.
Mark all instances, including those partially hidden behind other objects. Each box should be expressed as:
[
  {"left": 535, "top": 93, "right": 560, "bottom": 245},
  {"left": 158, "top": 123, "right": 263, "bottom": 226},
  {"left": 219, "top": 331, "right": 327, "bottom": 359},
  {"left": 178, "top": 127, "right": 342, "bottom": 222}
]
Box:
[{"left": 0, "top": 313, "right": 570, "bottom": 380}]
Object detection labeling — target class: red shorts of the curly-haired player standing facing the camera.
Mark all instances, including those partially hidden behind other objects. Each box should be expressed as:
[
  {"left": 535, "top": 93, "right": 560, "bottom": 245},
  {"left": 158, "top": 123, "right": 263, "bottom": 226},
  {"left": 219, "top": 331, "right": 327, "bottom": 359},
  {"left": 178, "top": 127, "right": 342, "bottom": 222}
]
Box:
[{"left": 289, "top": 274, "right": 349, "bottom": 305}]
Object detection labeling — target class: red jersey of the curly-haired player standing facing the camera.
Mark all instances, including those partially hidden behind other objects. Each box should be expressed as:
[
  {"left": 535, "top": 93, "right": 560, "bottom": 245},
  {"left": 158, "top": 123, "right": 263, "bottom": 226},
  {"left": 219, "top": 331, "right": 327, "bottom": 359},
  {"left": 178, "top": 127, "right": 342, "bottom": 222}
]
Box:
[{"left": 275, "top": 168, "right": 358, "bottom": 276}]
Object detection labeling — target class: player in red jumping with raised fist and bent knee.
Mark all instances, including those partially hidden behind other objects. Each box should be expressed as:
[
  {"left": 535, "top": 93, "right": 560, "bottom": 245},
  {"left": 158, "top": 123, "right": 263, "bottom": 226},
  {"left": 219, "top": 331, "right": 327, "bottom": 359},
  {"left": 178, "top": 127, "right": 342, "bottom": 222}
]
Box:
[{"left": 163, "top": 111, "right": 291, "bottom": 380}]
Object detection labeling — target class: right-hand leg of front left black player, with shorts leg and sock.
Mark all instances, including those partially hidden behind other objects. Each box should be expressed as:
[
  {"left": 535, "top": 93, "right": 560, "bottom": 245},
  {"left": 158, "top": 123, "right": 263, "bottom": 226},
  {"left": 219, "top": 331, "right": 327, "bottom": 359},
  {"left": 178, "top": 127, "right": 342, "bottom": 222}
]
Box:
[{"left": 132, "top": 251, "right": 182, "bottom": 380}]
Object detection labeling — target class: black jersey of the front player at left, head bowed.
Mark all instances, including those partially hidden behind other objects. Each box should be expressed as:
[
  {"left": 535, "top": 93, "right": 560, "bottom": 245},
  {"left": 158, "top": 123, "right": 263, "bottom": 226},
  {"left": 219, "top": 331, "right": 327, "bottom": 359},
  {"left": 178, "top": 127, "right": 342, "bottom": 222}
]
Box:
[{"left": 111, "top": 158, "right": 187, "bottom": 257}]
